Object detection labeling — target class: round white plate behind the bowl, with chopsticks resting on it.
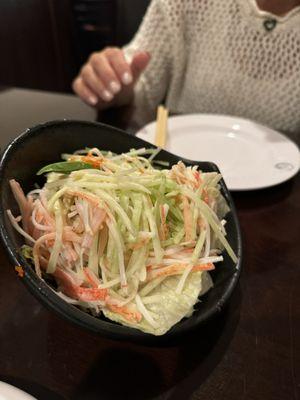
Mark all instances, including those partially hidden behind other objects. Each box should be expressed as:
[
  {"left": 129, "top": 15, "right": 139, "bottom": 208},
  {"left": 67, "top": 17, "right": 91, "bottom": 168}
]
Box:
[{"left": 137, "top": 114, "right": 300, "bottom": 190}]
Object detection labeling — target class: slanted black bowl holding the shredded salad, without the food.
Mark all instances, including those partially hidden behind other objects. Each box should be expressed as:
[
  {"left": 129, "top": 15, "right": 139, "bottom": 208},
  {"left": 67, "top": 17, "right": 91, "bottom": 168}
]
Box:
[{"left": 0, "top": 121, "right": 241, "bottom": 344}]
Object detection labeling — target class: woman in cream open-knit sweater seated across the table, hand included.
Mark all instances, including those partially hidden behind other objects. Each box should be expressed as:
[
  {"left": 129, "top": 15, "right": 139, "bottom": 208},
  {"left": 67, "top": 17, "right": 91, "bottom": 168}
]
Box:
[{"left": 73, "top": 0, "right": 300, "bottom": 133}]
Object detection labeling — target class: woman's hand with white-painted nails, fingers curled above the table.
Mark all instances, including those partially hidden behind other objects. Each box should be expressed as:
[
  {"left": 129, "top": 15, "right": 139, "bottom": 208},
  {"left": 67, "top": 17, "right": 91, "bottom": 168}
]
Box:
[{"left": 72, "top": 47, "right": 150, "bottom": 109}]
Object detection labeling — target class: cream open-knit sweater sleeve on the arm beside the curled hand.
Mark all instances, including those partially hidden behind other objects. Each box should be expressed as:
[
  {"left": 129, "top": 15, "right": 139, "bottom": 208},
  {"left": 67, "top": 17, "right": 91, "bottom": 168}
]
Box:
[{"left": 124, "top": 0, "right": 172, "bottom": 125}]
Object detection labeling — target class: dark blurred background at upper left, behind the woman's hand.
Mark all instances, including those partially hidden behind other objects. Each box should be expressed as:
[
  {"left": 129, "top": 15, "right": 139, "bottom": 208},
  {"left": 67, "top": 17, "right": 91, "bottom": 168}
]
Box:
[{"left": 0, "top": 0, "right": 150, "bottom": 92}]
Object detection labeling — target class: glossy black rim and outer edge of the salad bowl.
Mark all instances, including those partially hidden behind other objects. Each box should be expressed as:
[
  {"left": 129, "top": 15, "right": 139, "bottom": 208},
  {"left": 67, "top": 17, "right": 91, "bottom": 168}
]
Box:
[{"left": 0, "top": 119, "right": 242, "bottom": 345}]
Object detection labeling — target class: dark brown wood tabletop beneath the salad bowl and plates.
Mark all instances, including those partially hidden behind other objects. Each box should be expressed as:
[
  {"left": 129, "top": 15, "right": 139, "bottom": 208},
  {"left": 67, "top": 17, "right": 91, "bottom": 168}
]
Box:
[{"left": 0, "top": 89, "right": 300, "bottom": 400}]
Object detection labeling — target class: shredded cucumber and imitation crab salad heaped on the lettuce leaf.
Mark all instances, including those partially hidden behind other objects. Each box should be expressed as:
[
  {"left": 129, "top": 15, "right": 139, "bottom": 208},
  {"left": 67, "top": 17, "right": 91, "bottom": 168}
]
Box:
[{"left": 7, "top": 148, "right": 237, "bottom": 330}]
